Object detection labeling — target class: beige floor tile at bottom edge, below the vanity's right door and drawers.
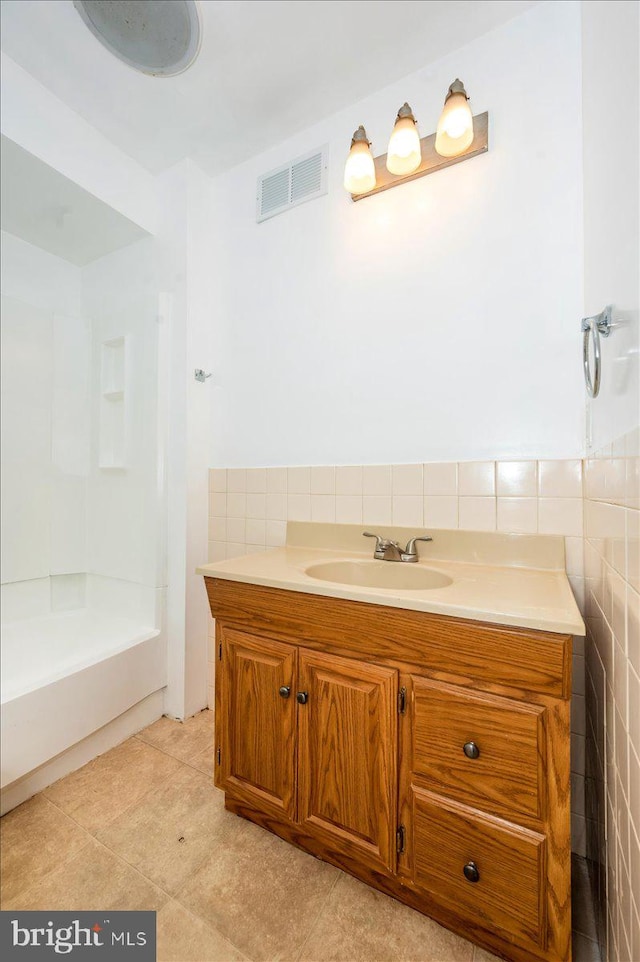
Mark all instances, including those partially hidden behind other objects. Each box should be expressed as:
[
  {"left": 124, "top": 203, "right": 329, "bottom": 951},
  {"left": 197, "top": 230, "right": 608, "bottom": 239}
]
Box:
[{"left": 298, "top": 875, "right": 474, "bottom": 962}]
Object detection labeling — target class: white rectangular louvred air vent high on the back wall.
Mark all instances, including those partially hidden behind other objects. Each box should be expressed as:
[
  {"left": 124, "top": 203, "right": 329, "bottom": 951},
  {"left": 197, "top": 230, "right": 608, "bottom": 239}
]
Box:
[{"left": 257, "top": 147, "right": 329, "bottom": 223}]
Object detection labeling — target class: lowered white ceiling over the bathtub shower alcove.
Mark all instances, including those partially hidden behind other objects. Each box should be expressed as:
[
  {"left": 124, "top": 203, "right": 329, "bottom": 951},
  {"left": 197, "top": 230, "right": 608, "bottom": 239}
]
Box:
[{"left": 0, "top": 136, "right": 147, "bottom": 267}]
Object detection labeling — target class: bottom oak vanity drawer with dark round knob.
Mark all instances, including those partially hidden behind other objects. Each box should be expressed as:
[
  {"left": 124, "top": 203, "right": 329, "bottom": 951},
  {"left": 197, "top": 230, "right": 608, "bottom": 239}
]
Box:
[{"left": 412, "top": 789, "right": 546, "bottom": 949}]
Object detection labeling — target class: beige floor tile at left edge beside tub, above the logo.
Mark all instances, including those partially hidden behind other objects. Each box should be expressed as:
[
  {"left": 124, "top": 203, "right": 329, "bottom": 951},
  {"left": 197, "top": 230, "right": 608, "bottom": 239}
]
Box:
[{"left": 0, "top": 795, "right": 91, "bottom": 907}]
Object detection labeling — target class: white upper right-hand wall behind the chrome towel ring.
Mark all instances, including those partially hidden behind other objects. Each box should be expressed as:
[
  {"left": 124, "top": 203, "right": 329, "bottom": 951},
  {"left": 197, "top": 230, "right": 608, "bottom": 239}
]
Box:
[{"left": 582, "top": 0, "right": 640, "bottom": 450}]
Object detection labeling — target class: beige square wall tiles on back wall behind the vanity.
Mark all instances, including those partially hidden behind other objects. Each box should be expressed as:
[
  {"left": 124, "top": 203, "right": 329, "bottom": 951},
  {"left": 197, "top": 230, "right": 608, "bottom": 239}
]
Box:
[{"left": 208, "top": 460, "right": 586, "bottom": 854}]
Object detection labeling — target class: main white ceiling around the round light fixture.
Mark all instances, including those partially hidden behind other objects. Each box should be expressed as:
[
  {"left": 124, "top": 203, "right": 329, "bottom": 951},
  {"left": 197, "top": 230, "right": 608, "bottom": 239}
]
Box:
[{"left": 1, "top": 0, "right": 538, "bottom": 173}]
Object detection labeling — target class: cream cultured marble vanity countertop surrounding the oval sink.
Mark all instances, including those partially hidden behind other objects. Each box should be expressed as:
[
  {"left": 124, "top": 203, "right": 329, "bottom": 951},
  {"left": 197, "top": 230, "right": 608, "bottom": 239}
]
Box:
[{"left": 197, "top": 522, "right": 585, "bottom": 635}]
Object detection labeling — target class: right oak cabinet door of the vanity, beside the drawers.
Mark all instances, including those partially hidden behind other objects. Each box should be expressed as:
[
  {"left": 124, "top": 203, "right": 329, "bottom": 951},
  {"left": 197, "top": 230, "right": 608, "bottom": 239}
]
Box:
[{"left": 298, "top": 649, "right": 397, "bottom": 871}]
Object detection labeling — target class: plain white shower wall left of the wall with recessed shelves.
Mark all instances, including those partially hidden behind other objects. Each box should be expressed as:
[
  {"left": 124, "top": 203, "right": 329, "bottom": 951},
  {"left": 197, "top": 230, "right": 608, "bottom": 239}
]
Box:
[{"left": 2, "top": 232, "right": 89, "bottom": 595}]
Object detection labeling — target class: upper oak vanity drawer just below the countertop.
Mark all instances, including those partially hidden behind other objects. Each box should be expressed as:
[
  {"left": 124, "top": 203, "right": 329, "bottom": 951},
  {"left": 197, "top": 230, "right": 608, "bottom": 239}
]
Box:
[{"left": 412, "top": 677, "right": 546, "bottom": 819}]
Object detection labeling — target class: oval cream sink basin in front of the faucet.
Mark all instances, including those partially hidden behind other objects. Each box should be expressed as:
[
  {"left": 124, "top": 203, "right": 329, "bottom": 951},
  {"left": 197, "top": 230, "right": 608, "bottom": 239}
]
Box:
[{"left": 305, "top": 561, "right": 453, "bottom": 591}]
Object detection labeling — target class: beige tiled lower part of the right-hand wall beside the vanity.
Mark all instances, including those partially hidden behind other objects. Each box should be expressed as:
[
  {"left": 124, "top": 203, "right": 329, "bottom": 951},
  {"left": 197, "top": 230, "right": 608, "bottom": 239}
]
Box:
[{"left": 584, "top": 430, "right": 640, "bottom": 962}]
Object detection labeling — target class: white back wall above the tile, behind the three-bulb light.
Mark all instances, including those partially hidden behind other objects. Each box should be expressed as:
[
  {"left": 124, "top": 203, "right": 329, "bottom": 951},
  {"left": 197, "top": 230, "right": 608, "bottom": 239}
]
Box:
[{"left": 210, "top": 2, "right": 583, "bottom": 466}]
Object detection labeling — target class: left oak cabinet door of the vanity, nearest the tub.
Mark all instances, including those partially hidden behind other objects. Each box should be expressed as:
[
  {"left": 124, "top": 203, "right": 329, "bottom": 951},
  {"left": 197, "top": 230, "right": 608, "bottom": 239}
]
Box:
[{"left": 218, "top": 628, "right": 296, "bottom": 819}]
